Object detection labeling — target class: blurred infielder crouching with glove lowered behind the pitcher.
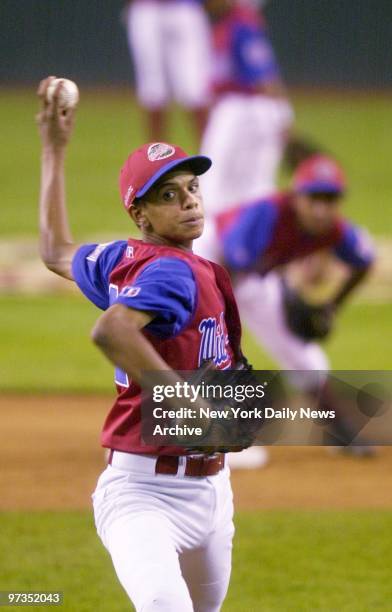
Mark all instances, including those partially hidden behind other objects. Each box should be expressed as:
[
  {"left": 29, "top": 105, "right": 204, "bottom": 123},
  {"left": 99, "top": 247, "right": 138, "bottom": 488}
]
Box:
[{"left": 195, "top": 155, "right": 374, "bottom": 467}]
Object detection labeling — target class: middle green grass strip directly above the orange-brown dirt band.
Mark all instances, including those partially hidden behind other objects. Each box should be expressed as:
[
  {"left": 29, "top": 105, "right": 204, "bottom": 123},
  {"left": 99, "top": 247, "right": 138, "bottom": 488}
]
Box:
[{"left": 0, "top": 295, "right": 392, "bottom": 393}]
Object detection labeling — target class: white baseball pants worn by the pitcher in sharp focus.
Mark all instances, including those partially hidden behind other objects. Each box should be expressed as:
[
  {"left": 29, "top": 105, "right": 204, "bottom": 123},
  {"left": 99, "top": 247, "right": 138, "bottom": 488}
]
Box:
[{"left": 93, "top": 453, "right": 234, "bottom": 612}]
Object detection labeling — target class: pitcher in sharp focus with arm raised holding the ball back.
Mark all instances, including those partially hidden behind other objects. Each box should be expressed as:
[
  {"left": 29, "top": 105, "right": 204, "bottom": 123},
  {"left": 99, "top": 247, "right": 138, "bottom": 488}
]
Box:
[{"left": 38, "top": 77, "right": 245, "bottom": 612}]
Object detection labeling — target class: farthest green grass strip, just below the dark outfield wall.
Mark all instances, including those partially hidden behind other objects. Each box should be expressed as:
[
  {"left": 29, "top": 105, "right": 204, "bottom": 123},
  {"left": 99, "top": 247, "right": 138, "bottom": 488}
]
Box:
[{"left": 0, "top": 90, "right": 392, "bottom": 239}]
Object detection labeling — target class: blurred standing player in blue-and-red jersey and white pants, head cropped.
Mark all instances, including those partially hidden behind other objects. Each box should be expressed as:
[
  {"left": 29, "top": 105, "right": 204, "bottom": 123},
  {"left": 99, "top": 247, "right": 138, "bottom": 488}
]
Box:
[{"left": 201, "top": 0, "right": 293, "bottom": 215}]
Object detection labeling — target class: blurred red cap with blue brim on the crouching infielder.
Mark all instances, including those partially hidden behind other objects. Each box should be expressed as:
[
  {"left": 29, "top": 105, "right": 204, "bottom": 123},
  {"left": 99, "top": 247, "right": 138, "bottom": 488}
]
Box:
[{"left": 293, "top": 155, "right": 346, "bottom": 195}]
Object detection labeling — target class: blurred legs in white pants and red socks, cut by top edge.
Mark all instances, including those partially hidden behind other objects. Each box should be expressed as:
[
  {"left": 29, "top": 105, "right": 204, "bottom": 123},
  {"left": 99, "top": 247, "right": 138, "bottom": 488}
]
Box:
[{"left": 124, "top": 0, "right": 211, "bottom": 141}]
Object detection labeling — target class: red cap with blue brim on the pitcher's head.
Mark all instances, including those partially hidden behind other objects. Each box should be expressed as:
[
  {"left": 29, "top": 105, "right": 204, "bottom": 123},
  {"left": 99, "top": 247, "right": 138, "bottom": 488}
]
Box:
[{"left": 120, "top": 142, "right": 212, "bottom": 210}]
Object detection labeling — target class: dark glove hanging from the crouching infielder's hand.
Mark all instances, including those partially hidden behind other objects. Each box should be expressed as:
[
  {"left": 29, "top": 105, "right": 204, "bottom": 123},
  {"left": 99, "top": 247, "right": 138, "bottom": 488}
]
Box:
[{"left": 283, "top": 284, "right": 335, "bottom": 340}]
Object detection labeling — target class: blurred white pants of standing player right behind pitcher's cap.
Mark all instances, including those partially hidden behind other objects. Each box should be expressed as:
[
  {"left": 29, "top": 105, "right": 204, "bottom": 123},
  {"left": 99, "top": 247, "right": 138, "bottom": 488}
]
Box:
[{"left": 200, "top": 93, "right": 293, "bottom": 215}]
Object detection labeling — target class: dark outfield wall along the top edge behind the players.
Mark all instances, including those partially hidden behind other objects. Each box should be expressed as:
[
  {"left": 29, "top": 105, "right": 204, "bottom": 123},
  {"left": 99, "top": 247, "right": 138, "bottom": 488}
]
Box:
[{"left": 0, "top": 0, "right": 392, "bottom": 88}]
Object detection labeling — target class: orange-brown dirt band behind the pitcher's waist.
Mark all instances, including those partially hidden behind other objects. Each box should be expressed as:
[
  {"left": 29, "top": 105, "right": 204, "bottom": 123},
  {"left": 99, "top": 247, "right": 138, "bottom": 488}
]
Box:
[{"left": 0, "top": 396, "right": 392, "bottom": 510}]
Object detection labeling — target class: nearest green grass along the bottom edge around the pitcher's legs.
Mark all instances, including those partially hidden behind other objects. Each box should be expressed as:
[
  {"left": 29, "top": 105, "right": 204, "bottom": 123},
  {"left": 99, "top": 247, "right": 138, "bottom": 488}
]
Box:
[{"left": 0, "top": 511, "right": 392, "bottom": 612}]
